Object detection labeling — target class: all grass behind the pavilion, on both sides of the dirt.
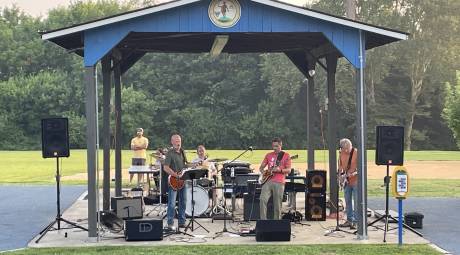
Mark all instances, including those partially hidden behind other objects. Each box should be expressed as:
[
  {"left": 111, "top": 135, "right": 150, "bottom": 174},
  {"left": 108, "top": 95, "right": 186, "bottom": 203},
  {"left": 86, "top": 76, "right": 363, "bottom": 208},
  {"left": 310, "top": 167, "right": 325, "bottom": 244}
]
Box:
[{"left": 0, "top": 150, "right": 460, "bottom": 197}]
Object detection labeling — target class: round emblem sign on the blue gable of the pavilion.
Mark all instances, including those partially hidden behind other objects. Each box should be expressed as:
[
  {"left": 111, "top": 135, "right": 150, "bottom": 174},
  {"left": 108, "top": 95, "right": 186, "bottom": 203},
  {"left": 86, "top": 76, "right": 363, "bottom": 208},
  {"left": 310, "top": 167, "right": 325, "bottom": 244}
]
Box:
[{"left": 208, "top": 0, "right": 241, "bottom": 28}]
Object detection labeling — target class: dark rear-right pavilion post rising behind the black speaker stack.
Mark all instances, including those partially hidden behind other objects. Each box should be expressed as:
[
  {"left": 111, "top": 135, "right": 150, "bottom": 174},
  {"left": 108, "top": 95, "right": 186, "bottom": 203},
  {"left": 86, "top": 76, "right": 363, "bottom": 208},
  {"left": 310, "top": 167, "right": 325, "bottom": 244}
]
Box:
[{"left": 306, "top": 54, "right": 317, "bottom": 171}]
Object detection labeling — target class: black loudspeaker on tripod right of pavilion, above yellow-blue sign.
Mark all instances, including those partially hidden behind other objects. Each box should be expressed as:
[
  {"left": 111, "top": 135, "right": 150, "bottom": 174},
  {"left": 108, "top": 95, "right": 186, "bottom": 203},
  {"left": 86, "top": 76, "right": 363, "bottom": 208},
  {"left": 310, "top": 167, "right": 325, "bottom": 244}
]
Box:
[{"left": 375, "top": 126, "right": 404, "bottom": 166}]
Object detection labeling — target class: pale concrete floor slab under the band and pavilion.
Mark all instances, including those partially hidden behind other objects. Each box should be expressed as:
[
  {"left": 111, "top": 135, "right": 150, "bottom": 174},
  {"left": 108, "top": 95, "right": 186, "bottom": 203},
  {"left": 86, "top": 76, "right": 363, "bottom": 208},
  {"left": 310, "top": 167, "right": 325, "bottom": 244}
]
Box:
[{"left": 28, "top": 190, "right": 430, "bottom": 247}]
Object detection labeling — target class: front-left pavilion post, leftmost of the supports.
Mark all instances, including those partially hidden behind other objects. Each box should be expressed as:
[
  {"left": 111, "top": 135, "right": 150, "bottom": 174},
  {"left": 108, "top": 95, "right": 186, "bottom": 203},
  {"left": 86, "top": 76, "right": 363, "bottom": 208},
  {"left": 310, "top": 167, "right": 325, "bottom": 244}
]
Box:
[{"left": 85, "top": 66, "right": 97, "bottom": 237}]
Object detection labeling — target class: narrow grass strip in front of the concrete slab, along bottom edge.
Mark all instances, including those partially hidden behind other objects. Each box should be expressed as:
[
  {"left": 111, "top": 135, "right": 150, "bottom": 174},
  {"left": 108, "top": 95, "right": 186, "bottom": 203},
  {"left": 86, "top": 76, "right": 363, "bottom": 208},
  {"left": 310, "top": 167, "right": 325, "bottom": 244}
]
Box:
[{"left": 1, "top": 244, "right": 441, "bottom": 255}]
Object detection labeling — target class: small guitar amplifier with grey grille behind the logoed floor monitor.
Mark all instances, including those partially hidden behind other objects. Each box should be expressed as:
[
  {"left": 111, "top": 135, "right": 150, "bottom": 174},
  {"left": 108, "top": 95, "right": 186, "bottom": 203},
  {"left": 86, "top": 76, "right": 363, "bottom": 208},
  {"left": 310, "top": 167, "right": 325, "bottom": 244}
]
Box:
[{"left": 110, "top": 197, "right": 143, "bottom": 220}]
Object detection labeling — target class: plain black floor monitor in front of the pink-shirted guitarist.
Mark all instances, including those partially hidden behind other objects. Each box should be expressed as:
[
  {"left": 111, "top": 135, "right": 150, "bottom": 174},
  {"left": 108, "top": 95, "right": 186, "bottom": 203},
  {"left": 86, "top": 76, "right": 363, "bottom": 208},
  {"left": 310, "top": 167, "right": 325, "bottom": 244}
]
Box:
[{"left": 256, "top": 220, "right": 291, "bottom": 242}]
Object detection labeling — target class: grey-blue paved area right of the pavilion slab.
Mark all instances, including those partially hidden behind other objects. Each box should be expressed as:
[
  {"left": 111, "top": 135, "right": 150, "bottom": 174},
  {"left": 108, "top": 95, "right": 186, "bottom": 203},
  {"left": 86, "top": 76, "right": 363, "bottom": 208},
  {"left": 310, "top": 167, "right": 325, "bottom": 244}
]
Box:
[{"left": 368, "top": 197, "right": 460, "bottom": 255}]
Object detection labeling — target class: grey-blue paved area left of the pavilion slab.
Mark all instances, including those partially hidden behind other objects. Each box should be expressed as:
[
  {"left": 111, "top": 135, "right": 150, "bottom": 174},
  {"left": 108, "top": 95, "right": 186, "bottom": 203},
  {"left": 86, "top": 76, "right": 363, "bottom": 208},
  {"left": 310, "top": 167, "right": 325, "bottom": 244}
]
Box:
[{"left": 0, "top": 185, "right": 86, "bottom": 251}]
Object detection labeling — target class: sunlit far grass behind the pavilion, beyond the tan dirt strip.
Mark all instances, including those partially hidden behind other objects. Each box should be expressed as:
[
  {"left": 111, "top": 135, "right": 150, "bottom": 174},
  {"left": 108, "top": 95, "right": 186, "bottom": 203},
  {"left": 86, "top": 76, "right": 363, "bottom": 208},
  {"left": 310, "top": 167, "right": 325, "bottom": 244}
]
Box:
[{"left": 0, "top": 150, "right": 460, "bottom": 184}]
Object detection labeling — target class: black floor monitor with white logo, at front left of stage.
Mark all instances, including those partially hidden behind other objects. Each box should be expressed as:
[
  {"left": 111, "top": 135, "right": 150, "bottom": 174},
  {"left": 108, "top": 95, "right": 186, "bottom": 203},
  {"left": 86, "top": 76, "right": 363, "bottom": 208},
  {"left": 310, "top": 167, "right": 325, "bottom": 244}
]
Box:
[{"left": 125, "top": 219, "right": 163, "bottom": 241}]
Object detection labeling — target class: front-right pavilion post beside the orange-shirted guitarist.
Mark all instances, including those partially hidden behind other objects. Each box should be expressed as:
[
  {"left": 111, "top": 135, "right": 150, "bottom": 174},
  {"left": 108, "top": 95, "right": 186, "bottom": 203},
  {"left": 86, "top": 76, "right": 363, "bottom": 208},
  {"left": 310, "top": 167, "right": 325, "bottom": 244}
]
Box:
[{"left": 356, "top": 30, "right": 369, "bottom": 240}]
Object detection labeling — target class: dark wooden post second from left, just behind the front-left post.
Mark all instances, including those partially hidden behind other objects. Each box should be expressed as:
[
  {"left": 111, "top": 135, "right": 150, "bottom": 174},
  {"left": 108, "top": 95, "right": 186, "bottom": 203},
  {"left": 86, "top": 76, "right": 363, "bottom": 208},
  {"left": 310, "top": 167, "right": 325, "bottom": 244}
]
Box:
[{"left": 102, "top": 56, "right": 112, "bottom": 210}]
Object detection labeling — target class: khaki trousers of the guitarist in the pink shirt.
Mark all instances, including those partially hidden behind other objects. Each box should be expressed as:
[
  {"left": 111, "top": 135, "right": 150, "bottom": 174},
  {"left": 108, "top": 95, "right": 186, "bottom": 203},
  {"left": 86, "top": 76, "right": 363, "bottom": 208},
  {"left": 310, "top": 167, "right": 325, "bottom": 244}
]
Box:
[{"left": 260, "top": 180, "right": 284, "bottom": 220}]
